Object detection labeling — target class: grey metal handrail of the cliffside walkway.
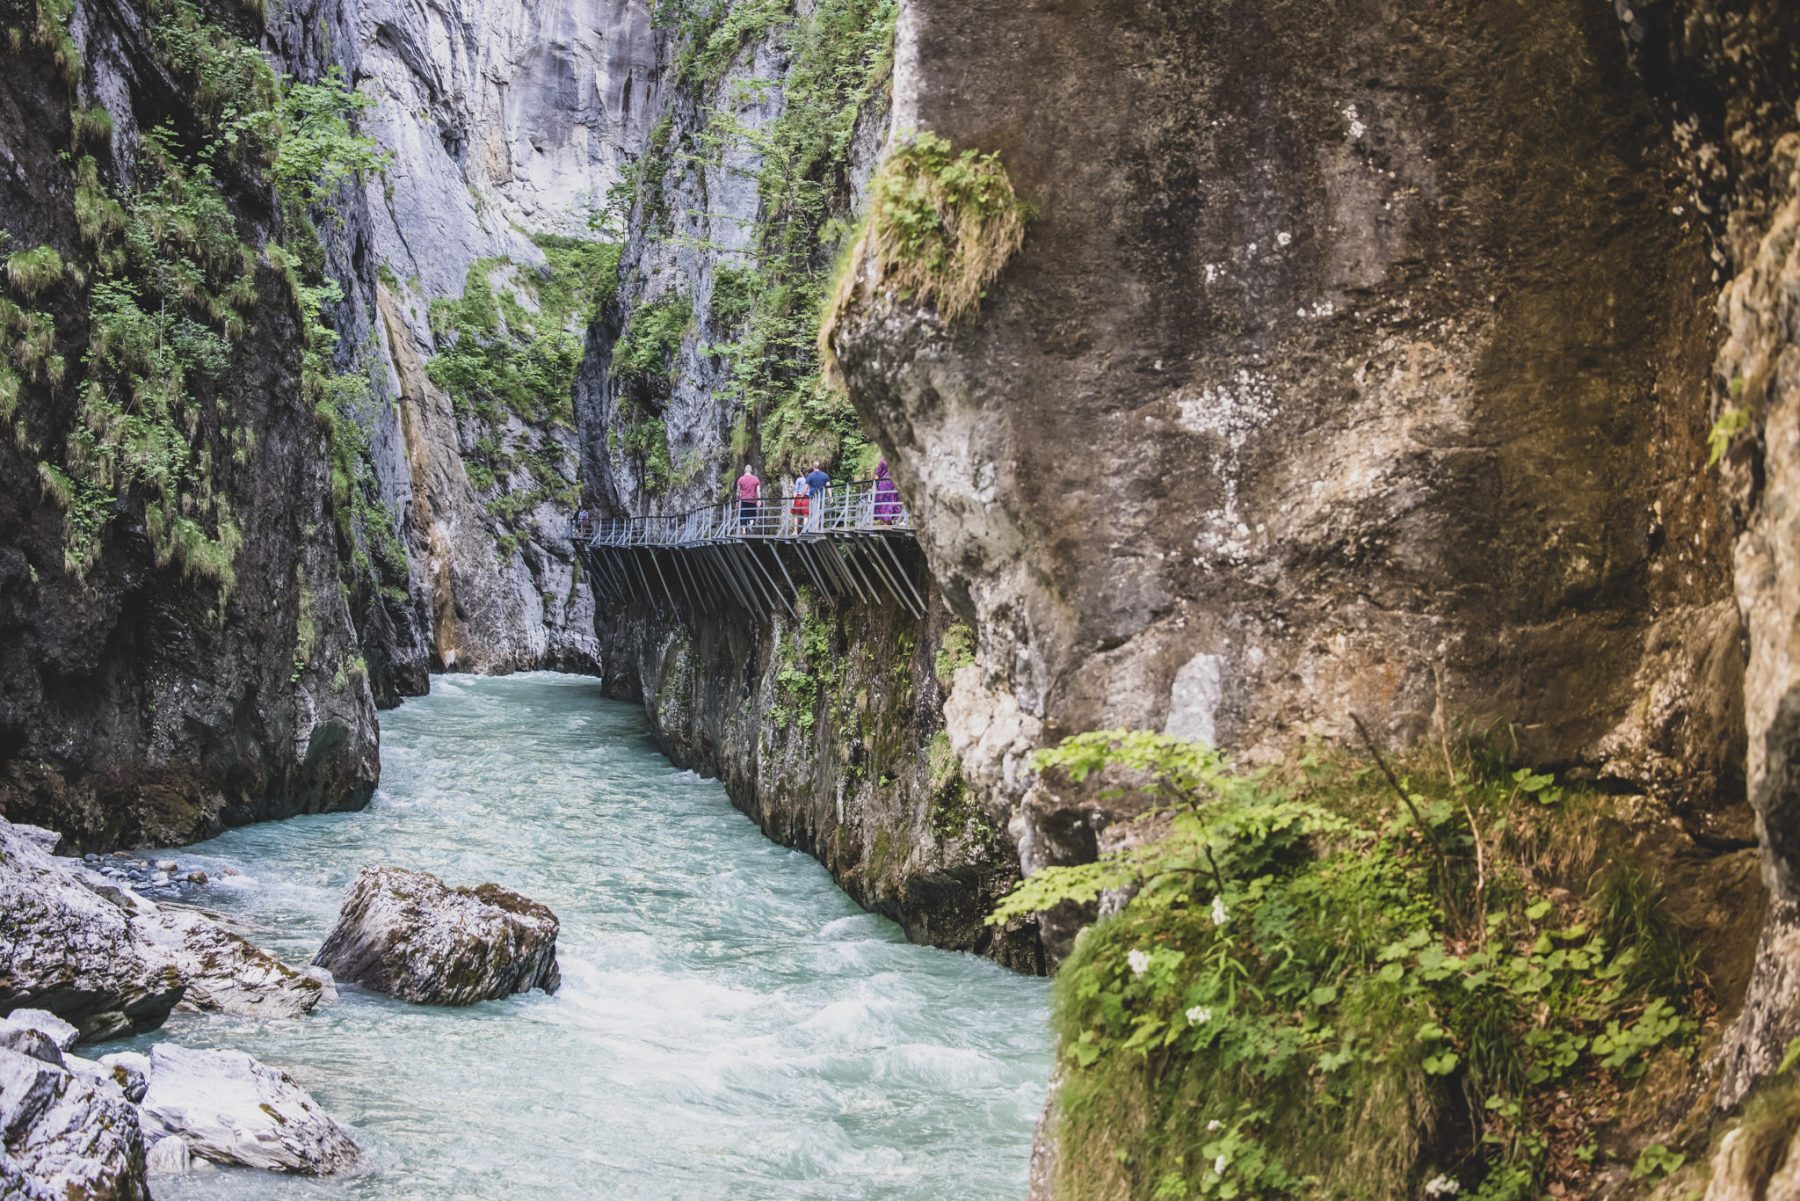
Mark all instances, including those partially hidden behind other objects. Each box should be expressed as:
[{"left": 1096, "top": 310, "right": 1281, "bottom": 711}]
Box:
[{"left": 567, "top": 479, "right": 913, "bottom": 547}]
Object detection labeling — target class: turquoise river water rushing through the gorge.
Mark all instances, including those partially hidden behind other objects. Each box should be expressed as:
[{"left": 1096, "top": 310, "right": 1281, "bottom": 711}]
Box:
[{"left": 116, "top": 675, "right": 1048, "bottom": 1201}]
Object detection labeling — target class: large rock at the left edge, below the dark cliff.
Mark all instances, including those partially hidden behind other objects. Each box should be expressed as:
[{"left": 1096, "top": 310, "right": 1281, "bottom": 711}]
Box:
[{"left": 0, "top": 821, "right": 184, "bottom": 1039}]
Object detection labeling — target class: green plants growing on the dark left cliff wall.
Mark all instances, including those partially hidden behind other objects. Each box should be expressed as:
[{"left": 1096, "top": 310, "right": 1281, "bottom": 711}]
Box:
[{"left": 0, "top": 0, "right": 392, "bottom": 607}]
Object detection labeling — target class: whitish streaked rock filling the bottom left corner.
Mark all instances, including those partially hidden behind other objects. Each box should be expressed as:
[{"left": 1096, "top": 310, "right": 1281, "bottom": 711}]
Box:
[{"left": 0, "top": 1032, "right": 149, "bottom": 1201}]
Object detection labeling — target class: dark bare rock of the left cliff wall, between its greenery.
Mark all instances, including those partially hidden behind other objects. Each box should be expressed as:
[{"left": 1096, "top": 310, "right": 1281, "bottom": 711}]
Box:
[{"left": 0, "top": 4, "right": 376, "bottom": 848}]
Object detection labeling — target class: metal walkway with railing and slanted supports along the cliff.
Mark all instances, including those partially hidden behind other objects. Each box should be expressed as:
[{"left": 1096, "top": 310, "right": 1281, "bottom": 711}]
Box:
[{"left": 569, "top": 479, "right": 925, "bottom": 621}]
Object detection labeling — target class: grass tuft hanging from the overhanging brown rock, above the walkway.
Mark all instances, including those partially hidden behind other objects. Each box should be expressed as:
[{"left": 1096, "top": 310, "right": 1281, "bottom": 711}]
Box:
[{"left": 819, "top": 133, "right": 1028, "bottom": 370}]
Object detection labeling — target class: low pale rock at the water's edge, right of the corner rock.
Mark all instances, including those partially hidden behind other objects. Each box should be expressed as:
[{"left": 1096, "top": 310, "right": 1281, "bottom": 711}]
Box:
[{"left": 139, "top": 1043, "right": 358, "bottom": 1176}]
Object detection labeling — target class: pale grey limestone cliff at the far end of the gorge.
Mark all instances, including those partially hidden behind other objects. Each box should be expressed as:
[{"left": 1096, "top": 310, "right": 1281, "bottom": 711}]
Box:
[{"left": 340, "top": 0, "right": 653, "bottom": 677}]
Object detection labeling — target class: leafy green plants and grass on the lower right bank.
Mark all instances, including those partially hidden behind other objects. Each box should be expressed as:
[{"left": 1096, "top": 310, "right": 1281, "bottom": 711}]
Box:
[{"left": 990, "top": 731, "right": 1696, "bottom": 1201}]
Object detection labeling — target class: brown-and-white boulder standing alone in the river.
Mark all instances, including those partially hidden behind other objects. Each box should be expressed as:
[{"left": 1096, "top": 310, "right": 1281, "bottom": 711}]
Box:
[{"left": 313, "top": 868, "right": 562, "bottom": 1005}]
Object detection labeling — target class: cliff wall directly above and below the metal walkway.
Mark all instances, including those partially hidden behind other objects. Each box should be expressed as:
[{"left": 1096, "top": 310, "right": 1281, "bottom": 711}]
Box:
[{"left": 576, "top": 2, "right": 1042, "bottom": 971}]
